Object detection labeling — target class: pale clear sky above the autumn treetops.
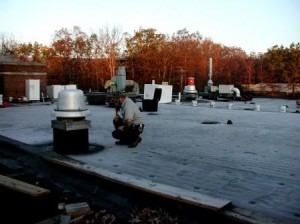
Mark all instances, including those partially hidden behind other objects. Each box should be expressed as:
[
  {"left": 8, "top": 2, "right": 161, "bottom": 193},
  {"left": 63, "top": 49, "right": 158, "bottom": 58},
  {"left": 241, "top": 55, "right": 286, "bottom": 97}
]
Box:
[{"left": 0, "top": 0, "right": 300, "bottom": 53}]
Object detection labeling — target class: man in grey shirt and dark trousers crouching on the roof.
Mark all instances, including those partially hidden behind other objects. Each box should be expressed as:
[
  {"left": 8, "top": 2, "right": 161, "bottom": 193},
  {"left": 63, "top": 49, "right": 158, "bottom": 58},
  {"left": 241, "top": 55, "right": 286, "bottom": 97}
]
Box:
[{"left": 112, "top": 94, "right": 144, "bottom": 148}]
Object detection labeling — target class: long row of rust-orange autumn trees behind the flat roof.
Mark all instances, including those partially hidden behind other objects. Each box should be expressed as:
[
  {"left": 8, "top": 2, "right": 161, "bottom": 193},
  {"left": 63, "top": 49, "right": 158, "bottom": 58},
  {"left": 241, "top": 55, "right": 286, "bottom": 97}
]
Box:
[{"left": 0, "top": 26, "right": 300, "bottom": 92}]
